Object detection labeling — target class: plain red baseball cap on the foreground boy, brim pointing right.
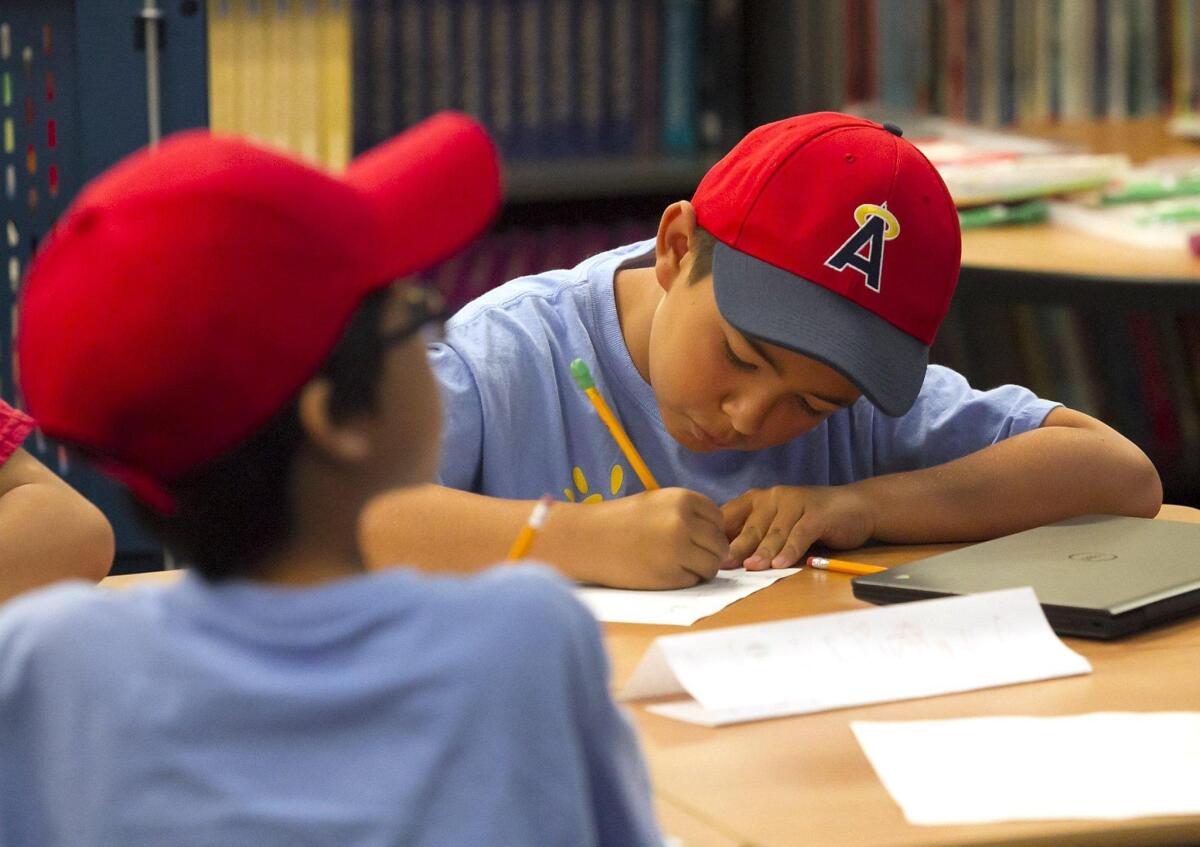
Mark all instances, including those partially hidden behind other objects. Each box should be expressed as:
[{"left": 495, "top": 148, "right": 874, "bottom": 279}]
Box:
[{"left": 18, "top": 113, "right": 500, "bottom": 507}]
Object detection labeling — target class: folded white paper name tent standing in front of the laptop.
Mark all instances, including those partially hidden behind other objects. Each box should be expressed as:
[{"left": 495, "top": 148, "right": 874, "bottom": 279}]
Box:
[{"left": 622, "top": 588, "right": 1092, "bottom": 726}]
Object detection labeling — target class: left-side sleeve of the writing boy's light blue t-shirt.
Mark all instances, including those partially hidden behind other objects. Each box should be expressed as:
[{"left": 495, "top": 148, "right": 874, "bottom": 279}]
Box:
[{"left": 428, "top": 343, "right": 484, "bottom": 491}]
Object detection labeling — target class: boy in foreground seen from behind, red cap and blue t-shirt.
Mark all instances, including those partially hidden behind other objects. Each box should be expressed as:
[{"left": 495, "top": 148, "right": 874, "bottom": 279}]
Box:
[{"left": 0, "top": 115, "right": 661, "bottom": 847}]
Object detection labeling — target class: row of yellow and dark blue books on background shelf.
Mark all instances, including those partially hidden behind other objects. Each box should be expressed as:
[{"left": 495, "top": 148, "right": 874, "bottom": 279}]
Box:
[{"left": 208, "top": 0, "right": 744, "bottom": 168}]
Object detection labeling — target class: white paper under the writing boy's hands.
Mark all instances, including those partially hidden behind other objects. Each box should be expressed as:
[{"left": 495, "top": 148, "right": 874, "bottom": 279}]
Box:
[{"left": 575, "top": 567, "right": 800, "bottom": 626}]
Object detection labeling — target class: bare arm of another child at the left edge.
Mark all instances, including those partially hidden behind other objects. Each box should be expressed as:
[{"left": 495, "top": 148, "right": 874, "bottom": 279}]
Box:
[{"left": 0, "top": 450, "right": 113, "bottom": 600}]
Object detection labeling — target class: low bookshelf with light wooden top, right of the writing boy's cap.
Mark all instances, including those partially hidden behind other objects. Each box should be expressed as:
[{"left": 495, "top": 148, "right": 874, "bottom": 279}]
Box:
[{"left": 934, "top": 116, "right": 1200, "bottom": 505}]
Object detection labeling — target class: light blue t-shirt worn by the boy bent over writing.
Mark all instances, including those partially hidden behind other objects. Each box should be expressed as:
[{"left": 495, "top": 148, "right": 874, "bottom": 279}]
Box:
[{"left": 430, "top": 241, "right": 1056, "bottom": 504}]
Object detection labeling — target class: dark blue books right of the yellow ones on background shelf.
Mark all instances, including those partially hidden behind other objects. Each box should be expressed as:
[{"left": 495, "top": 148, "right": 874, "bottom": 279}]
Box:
[{"left": 354, "top": 0, "right": 742, "bottom": 160}]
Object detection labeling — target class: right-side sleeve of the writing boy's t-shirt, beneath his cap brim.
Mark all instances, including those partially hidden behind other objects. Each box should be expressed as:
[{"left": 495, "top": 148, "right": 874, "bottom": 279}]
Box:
[{"left": 871, "top": 365, "right": 1058, "bottom": 475}]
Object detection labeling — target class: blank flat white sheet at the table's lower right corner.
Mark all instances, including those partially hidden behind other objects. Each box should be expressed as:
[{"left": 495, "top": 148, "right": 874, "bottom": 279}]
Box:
[{"left": 851, "top": 711, "right": 1200, "bottom": 825}]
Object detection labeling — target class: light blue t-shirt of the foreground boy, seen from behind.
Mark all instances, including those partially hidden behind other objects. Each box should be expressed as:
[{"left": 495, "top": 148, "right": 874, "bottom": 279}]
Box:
[{"left": 0, "top": 566, "right": 661, "bottom": 847}]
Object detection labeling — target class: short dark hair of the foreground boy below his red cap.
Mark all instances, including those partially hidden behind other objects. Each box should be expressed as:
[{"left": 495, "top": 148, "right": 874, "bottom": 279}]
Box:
[{"left": 130, "top": 288, "right": 388, "bottom": 582}]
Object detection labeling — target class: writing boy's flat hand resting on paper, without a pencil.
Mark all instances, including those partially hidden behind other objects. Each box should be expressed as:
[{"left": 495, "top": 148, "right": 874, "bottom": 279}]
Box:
[{"left": 721, "top": 486, "right": 875, "bottom": 571}]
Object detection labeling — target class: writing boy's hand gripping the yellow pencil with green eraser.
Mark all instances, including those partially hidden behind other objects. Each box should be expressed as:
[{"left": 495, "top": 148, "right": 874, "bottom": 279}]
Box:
[{"left": 566, "top": 488, "right": 730, "bottom": 589}]
